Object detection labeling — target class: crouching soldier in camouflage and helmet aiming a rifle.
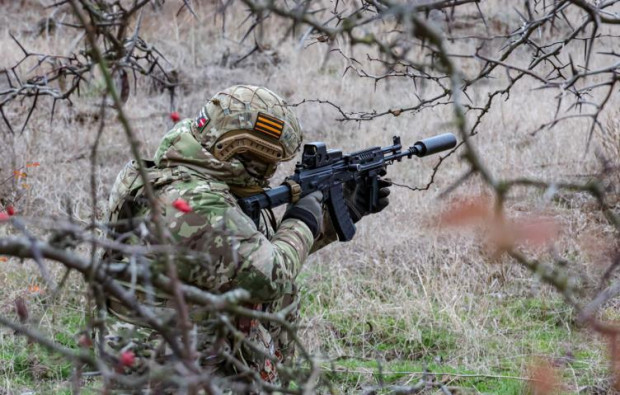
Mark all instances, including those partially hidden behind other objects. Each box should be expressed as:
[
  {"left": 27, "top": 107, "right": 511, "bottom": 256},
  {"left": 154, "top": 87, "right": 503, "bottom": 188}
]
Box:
[{"left": 103, "top": 85, "right": 389, "bottom": 392}]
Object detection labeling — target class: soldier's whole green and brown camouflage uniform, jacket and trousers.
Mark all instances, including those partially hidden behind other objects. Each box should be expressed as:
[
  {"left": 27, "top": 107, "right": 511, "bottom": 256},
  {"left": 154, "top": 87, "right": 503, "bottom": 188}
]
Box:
[{"left": 103, "top": 115, "right": 320, "bottom": 390}]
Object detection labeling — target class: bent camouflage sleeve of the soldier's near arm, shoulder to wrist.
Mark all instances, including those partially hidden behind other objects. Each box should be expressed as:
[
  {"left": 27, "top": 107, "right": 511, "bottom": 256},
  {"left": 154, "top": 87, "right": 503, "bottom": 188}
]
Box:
[{"left": 162, "top": 183, "right": 314, "bottom": 302}]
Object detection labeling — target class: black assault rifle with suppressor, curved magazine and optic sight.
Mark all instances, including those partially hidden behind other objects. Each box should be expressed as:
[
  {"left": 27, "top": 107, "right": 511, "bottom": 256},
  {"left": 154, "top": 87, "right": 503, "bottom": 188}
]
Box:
[{"left": 238, "top": 133, "right": 456, "bottom": 241}]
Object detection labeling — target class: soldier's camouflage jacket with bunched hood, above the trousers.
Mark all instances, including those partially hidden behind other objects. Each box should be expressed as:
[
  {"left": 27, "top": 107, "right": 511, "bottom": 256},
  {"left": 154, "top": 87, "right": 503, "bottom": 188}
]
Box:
[{"left": 109, "top": 119, "right": 335, "bottom": 303}]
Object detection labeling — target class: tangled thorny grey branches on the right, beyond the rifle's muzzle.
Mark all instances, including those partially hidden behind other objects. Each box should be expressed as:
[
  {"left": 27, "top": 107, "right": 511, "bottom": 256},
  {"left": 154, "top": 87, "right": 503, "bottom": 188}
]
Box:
[{"left": 225, "top": 0, "right": 620, "bottom": 390}]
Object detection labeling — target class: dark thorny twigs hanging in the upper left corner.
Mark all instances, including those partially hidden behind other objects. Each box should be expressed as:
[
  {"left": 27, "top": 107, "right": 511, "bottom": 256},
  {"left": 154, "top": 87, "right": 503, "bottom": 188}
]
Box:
[{"left": 0, "top": 0, "right": 177, "bottom": 133}]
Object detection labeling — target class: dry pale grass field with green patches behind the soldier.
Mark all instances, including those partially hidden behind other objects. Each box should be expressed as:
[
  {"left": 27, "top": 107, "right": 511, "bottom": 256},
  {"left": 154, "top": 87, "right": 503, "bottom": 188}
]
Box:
[{"left": 0, "top": 3, "right": 620, "bottom": 393}]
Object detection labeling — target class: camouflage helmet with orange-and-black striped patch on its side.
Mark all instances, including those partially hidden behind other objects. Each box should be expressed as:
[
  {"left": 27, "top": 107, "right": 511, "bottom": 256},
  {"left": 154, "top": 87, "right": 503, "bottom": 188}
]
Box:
[{"left": 194, "top": 85, "right": 302, "bottom": 178}]
